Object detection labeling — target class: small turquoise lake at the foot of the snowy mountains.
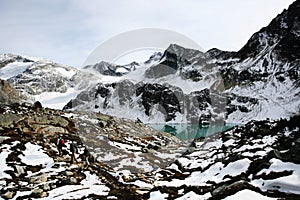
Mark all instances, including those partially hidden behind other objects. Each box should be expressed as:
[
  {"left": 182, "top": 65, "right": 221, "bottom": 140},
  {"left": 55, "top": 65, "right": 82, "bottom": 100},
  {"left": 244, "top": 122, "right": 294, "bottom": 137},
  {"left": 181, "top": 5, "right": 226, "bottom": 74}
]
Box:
[{"left": 148, "top": 124, "right": 236, "bottom": 140}]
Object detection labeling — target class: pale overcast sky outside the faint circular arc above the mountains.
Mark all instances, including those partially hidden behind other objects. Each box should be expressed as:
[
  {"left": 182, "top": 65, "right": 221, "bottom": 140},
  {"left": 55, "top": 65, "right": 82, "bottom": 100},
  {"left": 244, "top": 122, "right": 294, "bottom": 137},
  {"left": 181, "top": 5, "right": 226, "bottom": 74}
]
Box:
[{"left": 0, "top": 0, "right": 295, "bottom": 67}]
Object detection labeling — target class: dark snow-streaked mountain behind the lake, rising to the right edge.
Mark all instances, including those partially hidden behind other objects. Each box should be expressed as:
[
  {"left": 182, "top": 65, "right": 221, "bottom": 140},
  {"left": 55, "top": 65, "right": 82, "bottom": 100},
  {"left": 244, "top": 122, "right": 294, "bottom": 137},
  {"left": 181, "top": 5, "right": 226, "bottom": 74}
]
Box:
[{"left": 65, "top": 1, "right": 300, "bottom": 124}]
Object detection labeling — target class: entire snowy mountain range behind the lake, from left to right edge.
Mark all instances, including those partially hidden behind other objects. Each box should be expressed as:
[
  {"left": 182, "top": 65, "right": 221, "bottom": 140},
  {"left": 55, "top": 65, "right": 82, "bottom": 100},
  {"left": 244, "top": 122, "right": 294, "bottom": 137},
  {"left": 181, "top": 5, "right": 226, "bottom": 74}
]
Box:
[{"left": 0, "top": 2, "right": 300, "bottom": 124}]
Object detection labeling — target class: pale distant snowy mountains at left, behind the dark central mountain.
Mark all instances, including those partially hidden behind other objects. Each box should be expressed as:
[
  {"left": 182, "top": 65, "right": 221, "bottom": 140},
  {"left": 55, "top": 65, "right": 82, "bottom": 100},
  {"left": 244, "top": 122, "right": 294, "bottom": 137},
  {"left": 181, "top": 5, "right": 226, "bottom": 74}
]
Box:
[{"left": 0, "top": 53, "right": 161, "bottom": 109}]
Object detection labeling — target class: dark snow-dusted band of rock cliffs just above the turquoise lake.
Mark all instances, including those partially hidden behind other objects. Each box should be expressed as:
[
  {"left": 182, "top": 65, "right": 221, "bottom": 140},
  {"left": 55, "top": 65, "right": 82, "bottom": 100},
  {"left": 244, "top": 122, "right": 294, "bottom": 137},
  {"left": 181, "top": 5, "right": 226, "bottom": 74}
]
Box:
[{"left": 64, "top": 80, "right": 223, "bottom": 124}]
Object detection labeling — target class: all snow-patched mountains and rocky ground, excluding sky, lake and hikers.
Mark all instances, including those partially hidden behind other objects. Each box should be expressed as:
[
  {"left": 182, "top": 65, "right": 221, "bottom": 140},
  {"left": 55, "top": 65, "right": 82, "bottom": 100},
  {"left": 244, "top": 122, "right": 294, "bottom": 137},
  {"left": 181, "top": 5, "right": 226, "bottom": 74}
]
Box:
[{"left": 0, "top": 0, "right": 300, "bottom": 199}]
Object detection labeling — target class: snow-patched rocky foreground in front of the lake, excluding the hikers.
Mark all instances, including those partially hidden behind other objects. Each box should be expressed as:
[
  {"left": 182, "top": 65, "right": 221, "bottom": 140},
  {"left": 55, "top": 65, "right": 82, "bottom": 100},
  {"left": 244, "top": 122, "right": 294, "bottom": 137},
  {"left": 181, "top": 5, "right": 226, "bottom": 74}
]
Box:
[{"left": 0, "top": 104, "right": 300, "bottom": 199}]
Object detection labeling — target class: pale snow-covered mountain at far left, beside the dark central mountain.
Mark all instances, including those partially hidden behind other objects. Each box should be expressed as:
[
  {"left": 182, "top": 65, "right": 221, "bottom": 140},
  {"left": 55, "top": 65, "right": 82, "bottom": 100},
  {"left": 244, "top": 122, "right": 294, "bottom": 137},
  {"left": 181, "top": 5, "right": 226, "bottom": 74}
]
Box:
[{"left": 0, "top": 54, "right": 98, "bottom": 109}]
